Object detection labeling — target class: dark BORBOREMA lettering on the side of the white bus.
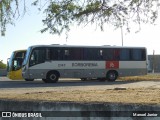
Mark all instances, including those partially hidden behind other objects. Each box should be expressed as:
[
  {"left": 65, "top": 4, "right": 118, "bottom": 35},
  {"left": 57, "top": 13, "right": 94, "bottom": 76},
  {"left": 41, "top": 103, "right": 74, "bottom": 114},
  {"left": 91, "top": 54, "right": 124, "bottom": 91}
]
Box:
[{"left": 72, "top": 63, "right": 98, "bottom": 67}]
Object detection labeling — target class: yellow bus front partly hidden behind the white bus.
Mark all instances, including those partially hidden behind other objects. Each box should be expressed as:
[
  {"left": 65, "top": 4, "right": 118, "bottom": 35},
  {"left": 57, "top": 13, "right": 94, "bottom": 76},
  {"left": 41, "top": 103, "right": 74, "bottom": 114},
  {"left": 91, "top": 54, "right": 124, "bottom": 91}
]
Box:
[{"left": 7, "top": 50, "right": 26, "bottom": 80}]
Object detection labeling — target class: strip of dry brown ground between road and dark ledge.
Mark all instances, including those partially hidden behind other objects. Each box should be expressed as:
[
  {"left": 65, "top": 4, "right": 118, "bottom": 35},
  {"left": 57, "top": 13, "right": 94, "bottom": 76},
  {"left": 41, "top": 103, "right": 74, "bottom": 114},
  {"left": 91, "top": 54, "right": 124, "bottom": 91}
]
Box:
[{"left": 0, "top": 74, "right": 160, "bottom": 104}]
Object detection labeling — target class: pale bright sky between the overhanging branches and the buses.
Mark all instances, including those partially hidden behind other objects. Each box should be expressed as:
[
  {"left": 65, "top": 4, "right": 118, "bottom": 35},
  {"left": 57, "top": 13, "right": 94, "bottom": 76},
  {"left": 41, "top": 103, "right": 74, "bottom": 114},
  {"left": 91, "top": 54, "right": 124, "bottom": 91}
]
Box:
[{"left": 0, "top": 0, "right": 160, "bottom": 63}]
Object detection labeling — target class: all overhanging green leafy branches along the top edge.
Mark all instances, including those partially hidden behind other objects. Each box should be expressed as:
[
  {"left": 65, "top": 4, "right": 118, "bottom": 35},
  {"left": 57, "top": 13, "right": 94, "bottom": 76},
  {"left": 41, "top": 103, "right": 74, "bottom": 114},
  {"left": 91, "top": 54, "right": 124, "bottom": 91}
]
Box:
[{"left": 0, "top": 0, "right": 159, "bottom": 35}]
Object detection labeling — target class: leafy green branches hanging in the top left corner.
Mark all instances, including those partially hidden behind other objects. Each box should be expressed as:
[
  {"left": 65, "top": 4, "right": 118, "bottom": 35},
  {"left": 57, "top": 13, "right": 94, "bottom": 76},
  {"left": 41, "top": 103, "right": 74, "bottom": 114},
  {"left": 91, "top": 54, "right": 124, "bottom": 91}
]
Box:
[{"left": 0, "top": 0, "right": 26, "bottom": 36}]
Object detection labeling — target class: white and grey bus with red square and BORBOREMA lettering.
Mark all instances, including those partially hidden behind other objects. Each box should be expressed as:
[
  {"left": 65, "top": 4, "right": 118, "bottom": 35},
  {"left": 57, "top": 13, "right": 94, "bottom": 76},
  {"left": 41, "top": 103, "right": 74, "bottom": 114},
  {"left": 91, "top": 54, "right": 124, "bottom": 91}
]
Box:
[{"left": 22, "top": 45, "right": 147, "bottom": 83}]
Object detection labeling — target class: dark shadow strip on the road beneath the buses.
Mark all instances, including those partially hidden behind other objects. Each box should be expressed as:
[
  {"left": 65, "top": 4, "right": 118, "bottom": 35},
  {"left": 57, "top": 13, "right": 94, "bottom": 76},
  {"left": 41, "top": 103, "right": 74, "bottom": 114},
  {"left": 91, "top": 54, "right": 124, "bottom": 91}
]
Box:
[{"left": 0, "top": 80, "right": 141, "bottom": 89}]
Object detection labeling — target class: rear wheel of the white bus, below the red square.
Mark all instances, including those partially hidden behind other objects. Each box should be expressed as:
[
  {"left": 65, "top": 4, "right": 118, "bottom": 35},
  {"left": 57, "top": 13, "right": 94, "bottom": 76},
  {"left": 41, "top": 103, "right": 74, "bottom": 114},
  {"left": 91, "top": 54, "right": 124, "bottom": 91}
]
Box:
[{"left": 107, "top": 70, "right": 118, "bottom": 82}]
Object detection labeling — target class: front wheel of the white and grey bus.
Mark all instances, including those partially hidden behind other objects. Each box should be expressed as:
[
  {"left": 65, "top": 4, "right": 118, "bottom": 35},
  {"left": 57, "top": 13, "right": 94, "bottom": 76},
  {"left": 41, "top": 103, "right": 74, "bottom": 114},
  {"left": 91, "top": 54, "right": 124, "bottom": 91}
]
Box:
[{"left": 43, "top": 71, "right": 59, "bottom": 83}]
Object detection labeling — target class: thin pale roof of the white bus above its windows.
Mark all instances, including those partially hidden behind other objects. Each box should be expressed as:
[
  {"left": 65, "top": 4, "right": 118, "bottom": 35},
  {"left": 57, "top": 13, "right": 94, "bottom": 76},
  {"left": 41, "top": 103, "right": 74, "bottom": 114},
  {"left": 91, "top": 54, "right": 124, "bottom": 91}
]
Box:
[{"left": 27, "top": 44, "right": 146, "bottom": 49}]
